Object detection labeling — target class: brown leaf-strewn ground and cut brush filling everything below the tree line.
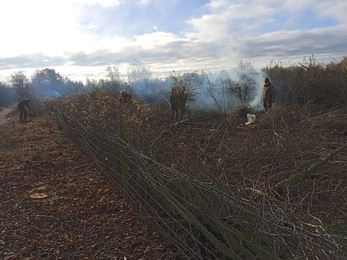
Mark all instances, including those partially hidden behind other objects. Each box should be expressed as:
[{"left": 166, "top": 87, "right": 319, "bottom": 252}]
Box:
[{"left": 0, "top": 93, "right": 347, "bottom": 259}]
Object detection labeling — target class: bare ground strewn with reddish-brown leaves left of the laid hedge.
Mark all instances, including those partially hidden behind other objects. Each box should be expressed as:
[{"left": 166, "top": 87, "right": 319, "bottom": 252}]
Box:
[{"left": 0, "top": 109, "right": 182, "bottom": 260}]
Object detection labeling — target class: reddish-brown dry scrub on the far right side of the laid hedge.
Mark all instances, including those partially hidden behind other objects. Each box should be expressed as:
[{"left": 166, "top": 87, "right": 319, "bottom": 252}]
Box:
[{"left": 167, "top": 106, "right": 347, "bottom": 230}]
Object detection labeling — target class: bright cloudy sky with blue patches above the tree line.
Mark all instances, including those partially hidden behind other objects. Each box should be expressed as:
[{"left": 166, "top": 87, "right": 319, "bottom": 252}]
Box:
[{"left": 0, "top": 0, "right": 347, "bottom": 81}]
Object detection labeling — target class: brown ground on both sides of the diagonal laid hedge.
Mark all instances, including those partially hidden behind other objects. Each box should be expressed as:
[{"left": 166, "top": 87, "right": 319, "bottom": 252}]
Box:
[{"left": 0, "top": 102, "right": 347, "bottom": 259}]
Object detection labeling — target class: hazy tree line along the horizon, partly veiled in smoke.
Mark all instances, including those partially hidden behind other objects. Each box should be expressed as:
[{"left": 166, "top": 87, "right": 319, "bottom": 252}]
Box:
[{"left": 0, "top": 55, "right": 347, "bottom": 112}]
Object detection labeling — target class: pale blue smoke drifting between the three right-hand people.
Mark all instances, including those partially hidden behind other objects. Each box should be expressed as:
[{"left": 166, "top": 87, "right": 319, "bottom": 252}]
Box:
[{"left": 130, "top": 66, "right": 266, "bottom": 111}]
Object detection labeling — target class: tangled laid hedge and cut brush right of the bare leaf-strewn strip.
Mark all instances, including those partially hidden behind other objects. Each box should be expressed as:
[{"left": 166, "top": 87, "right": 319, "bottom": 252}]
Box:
[{"left": 47, "top": 89, "right": 347, "bottom": 259}]
